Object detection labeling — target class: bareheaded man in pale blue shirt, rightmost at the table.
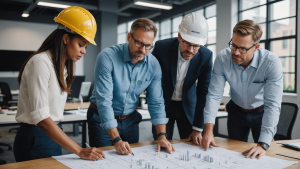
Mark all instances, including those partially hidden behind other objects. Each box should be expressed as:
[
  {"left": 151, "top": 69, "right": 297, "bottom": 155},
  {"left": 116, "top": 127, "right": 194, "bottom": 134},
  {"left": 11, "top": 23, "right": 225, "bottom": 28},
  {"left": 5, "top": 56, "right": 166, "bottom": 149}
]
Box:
[{"left": 202, "top": 20, "right": 283, "bottom": 159}]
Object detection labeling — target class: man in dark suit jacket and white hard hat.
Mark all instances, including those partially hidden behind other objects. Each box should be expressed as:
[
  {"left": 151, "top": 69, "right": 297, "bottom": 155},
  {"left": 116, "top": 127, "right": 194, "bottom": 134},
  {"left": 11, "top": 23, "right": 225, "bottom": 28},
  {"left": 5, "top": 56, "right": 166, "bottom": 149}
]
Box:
[{"left": 152, "top": 13, "right": 213, "bottom": 145}]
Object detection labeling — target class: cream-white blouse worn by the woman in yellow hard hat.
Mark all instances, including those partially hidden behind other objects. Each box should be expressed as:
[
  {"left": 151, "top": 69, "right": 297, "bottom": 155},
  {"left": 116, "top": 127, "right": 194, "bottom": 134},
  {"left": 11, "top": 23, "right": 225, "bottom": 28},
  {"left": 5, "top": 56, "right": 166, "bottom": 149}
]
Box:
[{"left": 16, "top": 51, "right": 67, "bottom": 125}]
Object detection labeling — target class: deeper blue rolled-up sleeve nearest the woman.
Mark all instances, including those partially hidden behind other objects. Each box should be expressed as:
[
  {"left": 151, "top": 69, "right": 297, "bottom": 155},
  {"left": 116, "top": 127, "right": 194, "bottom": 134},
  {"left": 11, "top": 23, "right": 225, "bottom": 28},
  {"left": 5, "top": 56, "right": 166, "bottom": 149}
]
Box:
[{"left": 95, "top": 52, "right": 118, "bottom": 130}]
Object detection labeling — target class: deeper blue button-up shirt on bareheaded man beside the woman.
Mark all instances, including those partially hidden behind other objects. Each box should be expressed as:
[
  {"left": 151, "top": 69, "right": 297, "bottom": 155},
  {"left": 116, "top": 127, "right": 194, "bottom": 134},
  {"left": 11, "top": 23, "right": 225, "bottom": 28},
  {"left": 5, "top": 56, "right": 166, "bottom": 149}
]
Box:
[{"left": 90, "top": 43, "right": 168, "bottom": 130}]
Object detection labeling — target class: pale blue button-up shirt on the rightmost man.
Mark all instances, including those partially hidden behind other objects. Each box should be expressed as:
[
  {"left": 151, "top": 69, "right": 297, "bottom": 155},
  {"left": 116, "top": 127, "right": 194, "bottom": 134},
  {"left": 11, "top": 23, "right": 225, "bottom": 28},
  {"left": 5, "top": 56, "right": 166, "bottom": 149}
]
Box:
[{"left": 204, "top": 48, "right": 283, "bottom": 145}]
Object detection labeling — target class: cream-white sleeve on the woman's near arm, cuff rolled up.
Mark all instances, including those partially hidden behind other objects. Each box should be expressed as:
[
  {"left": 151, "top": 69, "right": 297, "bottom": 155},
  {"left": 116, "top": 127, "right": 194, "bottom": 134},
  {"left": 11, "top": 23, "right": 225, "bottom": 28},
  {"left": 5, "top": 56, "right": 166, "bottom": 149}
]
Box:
[{"left": 24, "top": 59, "right": 51, "bottom": 125}]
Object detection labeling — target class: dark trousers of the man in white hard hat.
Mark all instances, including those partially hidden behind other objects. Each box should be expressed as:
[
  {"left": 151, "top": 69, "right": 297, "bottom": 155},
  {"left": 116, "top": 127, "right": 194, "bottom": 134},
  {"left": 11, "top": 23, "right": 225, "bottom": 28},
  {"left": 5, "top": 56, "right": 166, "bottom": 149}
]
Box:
[{"left": 152, "top": 100, "right": 193, "bottom": 140}]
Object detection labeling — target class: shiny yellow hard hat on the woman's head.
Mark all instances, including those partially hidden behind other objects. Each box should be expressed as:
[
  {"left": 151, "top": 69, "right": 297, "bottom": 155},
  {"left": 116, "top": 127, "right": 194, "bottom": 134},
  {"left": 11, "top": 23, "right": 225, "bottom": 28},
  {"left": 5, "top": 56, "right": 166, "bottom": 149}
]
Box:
[{"left": 54, "top": 6, "right": 97, "bottom": 46}]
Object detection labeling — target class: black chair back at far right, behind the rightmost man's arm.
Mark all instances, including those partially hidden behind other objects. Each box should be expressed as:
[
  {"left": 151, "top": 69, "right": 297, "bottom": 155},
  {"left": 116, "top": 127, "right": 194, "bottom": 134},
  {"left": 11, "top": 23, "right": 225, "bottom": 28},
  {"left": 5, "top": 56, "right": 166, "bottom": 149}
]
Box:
[{"left": 274, "top": 102, "right": 299, "bottom": 140}]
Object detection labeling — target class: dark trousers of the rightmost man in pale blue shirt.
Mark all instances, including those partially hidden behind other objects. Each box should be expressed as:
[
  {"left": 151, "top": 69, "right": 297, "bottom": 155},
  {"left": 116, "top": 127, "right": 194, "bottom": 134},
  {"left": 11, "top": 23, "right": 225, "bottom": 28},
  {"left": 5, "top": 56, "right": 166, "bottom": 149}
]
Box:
[{"left": 226, "top": 100, "right": 264, "bottom": 143}]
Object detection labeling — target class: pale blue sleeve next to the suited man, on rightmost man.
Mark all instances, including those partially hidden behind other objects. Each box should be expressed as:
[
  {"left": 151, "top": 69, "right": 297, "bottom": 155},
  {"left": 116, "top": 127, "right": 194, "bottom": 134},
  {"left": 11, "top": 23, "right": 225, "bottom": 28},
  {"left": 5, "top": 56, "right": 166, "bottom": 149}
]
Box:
[{"left": 204, "top": 54, "right": 226, "bottom": 124}]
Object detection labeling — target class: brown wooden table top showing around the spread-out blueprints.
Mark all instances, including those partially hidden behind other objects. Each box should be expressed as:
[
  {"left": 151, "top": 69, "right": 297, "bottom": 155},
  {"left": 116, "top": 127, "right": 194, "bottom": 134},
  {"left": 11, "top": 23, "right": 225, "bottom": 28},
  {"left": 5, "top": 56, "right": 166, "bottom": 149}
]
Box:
[{"left": 0, "top": 137, "right": 300, "bottom": 169}]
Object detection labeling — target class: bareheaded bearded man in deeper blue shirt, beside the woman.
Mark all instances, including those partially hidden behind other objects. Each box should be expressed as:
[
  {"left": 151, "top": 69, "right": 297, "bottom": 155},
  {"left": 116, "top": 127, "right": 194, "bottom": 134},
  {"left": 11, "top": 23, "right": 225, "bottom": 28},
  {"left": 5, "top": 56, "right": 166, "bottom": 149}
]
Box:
[{"left": 87, "top": 18, "right": 175, "bottom": 155}]
